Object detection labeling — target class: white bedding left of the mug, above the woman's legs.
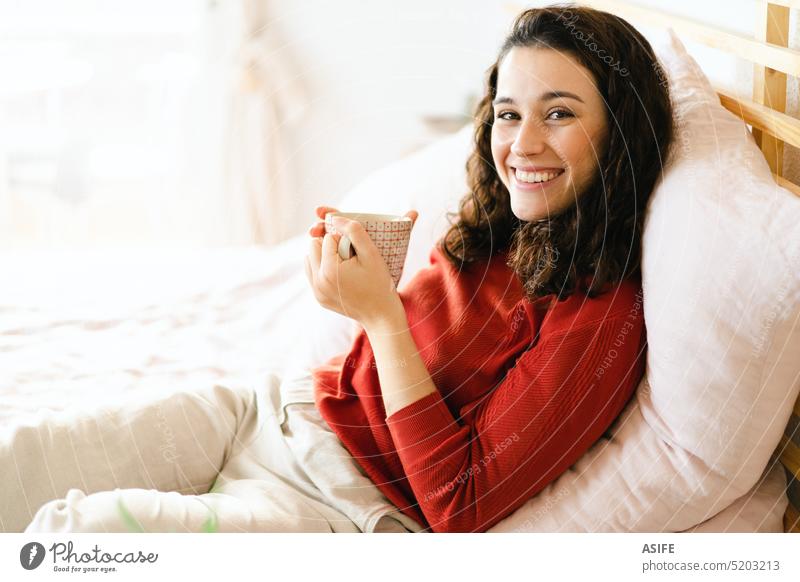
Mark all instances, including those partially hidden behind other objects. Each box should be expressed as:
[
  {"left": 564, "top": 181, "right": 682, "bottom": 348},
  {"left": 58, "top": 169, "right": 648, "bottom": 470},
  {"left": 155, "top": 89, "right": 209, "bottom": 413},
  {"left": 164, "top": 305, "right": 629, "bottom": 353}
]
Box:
[{"left": 0, "top": 237, "right": 324, "bottom": 423}]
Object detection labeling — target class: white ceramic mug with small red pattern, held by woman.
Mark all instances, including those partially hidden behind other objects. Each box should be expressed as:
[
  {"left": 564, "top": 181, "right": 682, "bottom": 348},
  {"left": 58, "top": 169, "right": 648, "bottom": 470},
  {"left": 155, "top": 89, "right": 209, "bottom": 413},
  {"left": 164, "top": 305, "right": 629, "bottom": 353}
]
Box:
[{"left": 325, "top": 212, "right": 413, "bottom": 287}]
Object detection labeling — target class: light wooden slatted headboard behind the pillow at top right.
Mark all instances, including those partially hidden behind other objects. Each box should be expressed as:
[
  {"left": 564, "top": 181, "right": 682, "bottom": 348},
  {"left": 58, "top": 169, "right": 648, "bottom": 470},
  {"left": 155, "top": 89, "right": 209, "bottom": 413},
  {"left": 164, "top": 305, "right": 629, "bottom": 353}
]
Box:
[{"left": 508, "top": 0, "right": 800, "bottom": 196}]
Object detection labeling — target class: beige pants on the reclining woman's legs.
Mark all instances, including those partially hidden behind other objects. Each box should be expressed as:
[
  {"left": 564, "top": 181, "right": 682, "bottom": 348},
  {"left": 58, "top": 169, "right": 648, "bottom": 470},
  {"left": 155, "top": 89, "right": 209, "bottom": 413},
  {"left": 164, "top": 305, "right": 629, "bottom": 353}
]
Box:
[{"left": 0, "top": 372, "right": 422, "bottom": 532}]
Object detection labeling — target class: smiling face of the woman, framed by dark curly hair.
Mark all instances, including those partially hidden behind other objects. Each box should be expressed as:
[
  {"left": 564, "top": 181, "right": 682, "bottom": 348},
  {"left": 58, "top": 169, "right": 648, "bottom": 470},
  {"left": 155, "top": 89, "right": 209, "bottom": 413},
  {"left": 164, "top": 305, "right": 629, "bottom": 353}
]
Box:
[{"left": 492, "top": 47, "right": 608, "bottom": 222}]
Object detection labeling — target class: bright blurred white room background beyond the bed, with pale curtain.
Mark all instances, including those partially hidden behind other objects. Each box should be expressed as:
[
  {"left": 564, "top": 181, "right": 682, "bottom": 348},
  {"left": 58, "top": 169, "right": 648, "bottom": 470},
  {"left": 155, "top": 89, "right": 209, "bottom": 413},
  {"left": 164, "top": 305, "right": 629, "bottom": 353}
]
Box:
[{"left": 0, "top": 0, "right": 509, "bottom": 249}]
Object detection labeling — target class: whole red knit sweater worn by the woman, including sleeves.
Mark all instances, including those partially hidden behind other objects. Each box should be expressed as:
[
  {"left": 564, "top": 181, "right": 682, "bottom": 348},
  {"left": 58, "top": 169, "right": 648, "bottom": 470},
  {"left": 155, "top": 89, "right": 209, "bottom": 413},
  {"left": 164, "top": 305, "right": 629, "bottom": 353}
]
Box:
[{"left": 313, "top": 247, "right": 646, "bottom": 532}]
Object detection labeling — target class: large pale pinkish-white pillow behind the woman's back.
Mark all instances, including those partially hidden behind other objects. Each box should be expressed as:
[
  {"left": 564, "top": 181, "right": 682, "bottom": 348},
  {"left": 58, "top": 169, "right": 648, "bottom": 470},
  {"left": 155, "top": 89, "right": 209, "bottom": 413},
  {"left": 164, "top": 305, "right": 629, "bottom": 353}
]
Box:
[{"left": 492, "top": 31, "right": 800, "bottom": 531}]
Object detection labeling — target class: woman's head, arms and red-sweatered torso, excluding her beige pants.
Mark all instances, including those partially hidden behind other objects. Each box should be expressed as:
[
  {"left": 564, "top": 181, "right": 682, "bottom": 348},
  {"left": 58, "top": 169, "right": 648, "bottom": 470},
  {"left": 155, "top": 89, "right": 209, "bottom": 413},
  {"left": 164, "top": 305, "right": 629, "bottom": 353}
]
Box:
[{"left": 307, "top": 7, "right": 673, "bottom": 531}]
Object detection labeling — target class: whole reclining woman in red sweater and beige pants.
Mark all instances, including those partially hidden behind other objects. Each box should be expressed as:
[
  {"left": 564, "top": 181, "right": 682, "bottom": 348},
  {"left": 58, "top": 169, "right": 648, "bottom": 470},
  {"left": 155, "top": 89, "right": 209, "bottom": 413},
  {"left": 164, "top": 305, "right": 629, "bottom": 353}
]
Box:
[{"left": 0, "top": 8, "right": 672, "bottom": 532}]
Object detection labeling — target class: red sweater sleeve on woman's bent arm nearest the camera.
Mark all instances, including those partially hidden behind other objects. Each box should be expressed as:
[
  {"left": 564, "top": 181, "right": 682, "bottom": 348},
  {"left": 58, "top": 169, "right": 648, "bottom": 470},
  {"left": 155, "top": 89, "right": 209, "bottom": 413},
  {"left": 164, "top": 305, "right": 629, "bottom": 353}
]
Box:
[{"left": 386, "top": 316, "right": 646, "bottom": 532}]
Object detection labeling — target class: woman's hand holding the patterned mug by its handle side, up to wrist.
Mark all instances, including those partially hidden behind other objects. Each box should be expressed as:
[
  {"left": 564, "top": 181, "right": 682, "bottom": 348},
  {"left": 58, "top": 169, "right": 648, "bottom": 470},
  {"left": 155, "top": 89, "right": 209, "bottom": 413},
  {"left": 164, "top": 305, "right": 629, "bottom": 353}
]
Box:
[{"left": 305, "top": 206, "right": 418, "bottom": 328}]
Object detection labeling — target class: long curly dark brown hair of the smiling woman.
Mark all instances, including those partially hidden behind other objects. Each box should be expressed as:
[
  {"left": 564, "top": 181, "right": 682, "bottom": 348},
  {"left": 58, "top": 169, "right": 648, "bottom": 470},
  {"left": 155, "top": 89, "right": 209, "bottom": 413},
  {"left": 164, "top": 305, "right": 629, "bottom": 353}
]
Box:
[{"left": 437, "top": 4, "right": 674, "bottom": 300}]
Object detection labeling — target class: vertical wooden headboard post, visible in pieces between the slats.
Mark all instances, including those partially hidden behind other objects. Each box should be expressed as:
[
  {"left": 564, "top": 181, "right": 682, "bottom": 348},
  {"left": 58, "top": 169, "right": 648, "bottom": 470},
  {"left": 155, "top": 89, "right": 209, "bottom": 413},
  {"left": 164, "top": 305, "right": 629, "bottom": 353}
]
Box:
[{"left": 753, "top": 3, "right": 789, "bottom": 176}]
